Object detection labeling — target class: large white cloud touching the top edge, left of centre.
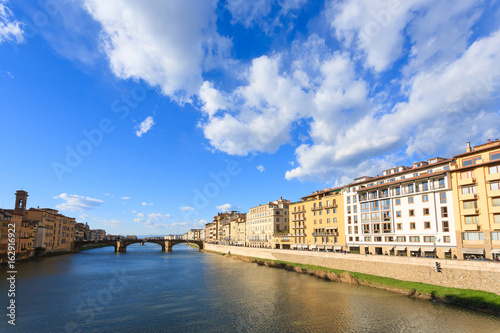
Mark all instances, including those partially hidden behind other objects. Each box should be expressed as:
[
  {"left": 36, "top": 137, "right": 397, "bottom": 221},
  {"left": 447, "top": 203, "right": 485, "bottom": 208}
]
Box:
[{"left": 85, "top": 0, "right": 231, "bottom": 103}]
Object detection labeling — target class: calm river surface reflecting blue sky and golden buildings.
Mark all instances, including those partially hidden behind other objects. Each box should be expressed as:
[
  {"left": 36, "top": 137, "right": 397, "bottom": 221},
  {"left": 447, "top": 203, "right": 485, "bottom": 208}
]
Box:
[{"left": 0, "top": 244, "right": 500, "bottom": 333}]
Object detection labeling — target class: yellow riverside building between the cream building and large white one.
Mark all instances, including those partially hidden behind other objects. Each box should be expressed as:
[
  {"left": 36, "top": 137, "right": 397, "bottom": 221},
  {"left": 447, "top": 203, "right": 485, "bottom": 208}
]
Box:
[{"left": 290, "top": 188, "right": 345, "bottom": 251}]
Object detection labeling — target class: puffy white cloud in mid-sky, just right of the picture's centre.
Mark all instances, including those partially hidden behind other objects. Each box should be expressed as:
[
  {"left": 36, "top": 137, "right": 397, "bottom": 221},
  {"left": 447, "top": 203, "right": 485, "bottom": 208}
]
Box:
[{"left": 202, "top": 56, "right": 313, "bottom": 156}]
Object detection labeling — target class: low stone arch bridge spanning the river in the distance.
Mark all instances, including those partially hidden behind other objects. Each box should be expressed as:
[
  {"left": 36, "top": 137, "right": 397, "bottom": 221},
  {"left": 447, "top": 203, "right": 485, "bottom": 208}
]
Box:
[{"left": 74, "top": 238, "right": 203, "bottom": 252}]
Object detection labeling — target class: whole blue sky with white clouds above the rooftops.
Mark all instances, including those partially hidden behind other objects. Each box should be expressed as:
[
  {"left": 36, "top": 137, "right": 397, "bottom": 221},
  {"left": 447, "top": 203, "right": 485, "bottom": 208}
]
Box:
[{"left": 0, "top": 0, "right": 500, "bottom": 235}]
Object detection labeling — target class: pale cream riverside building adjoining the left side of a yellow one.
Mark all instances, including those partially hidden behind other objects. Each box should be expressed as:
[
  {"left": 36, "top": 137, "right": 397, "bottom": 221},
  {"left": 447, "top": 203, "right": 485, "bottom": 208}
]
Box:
[{"left": 246, "top": 198, "right": 290, "bottom": 248}]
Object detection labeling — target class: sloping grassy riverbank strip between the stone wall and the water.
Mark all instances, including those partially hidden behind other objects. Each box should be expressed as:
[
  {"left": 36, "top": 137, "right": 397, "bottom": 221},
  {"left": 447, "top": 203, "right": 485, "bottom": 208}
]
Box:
[{"left": 206, "top": 251, "right": 500, "bottom": 315}]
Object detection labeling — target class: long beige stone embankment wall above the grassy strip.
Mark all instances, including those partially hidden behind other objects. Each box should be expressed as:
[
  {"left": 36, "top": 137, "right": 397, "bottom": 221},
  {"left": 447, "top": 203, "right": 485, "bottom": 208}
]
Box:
[{"left": 205, "top": 244, "right": 500, "bottom": 295}]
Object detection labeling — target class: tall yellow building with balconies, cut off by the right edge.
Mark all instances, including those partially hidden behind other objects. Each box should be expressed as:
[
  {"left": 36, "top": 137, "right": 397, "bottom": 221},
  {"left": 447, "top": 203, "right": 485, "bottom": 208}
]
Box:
[{"left": 450, "top": 139, "right": 500, "bottom": 259}]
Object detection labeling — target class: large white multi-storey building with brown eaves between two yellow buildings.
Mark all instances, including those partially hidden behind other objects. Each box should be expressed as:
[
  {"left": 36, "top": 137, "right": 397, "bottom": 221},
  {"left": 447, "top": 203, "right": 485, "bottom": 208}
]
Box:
[{"left": 344, "top": 157, "right": 456, "bottom": 258}]
